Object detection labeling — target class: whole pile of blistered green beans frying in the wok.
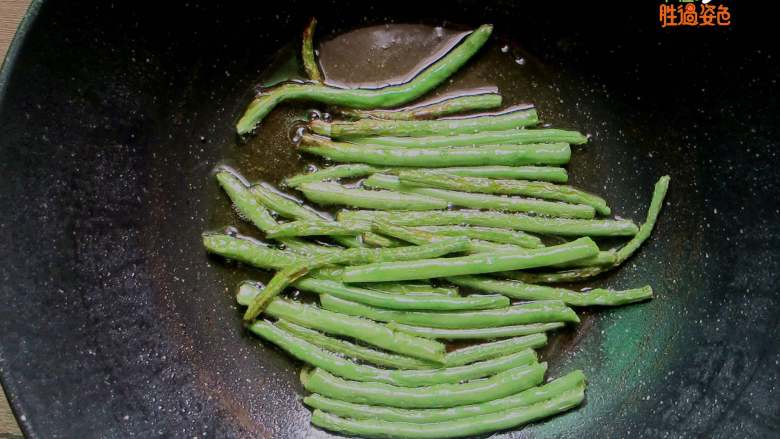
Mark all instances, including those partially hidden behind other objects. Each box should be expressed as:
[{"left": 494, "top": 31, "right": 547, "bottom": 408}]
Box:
[{"left": 209, "top": 18, "right": 670, "bottom": 439}]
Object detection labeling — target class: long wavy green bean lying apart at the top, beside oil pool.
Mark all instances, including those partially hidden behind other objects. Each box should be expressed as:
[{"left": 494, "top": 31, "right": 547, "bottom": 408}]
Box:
[{"left": 236, "top": 25, "right": 493, "bottom": 135}]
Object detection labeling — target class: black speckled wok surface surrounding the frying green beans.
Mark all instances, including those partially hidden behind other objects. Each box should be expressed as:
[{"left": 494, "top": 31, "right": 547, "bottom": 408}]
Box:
[{"left": 0, "top": 0, "right": 780, "bottom": 438}]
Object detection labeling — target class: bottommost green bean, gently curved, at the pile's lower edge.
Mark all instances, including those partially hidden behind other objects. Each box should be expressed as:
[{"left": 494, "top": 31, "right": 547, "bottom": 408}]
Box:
[{"left": 311, "top": 385, "right": 585, "bottom": 439}]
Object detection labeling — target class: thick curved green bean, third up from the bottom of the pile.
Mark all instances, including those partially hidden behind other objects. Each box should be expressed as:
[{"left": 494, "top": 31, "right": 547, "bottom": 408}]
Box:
[{"left": 301, "top": 363, "right": 547, "bottom": 408}]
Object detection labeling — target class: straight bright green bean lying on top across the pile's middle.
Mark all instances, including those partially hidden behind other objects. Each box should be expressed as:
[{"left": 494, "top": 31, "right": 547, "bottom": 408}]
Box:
[{"left": 342, "top": 237, "right": 599, "bottom": 283}]
